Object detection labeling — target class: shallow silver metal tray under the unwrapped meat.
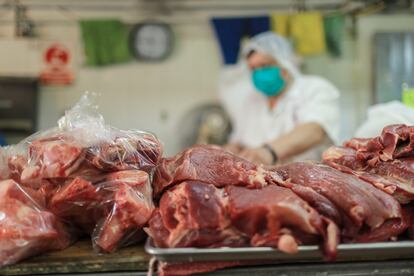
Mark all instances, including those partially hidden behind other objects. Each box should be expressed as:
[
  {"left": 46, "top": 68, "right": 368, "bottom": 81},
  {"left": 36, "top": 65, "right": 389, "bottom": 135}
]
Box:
[{"left": 145, "top": 238, "right": 414, "bottom": 263}]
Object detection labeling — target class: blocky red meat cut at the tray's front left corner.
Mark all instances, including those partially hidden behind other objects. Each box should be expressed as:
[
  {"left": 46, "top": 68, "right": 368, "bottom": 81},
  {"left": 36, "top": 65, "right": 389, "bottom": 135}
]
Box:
[{"left": 146, "top": 181, "right": 248, "bottom": 247}]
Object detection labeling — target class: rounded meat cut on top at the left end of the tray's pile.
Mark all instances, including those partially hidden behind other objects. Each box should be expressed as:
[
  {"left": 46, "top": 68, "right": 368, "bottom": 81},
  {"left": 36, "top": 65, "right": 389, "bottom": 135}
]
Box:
[{"left": 153, "top": 145, "right": 267, "bottom": 197}]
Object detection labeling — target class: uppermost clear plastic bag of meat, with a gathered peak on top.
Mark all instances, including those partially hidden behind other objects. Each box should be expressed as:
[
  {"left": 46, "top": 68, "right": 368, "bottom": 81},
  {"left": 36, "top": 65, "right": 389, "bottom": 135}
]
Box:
[{"left": 17, "top": 93, "right": 162, "bottom": 188}]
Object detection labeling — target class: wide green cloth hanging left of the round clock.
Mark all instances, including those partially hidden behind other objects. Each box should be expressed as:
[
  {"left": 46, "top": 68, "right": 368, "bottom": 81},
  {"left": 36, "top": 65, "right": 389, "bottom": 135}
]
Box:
[{"left": 80, "top": 19, "right": 132, "bottom": 66}]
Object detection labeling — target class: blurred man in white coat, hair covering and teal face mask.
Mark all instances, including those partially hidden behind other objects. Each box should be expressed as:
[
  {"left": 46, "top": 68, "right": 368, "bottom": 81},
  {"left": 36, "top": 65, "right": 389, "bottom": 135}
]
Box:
[{"left": 220, "top": 32, "right": 339, "bottom": 165}]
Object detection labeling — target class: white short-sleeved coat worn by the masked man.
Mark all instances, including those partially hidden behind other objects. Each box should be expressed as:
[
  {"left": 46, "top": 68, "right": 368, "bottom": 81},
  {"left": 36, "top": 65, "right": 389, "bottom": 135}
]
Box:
[{"left": 219, "top": 65, "right": 339, "bottom": 161}]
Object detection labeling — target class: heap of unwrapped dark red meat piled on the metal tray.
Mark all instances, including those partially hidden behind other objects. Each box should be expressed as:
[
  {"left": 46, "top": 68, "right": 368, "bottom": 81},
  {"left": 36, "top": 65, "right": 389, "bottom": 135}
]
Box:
[{"left": 145, "top": 125, "right": 414, "bottom": 274}]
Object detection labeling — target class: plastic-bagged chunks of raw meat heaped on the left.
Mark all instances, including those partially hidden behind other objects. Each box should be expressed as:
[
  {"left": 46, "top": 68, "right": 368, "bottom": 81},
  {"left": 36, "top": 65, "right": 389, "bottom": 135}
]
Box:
[{"left": 0, "top": 94, "right": 162, "bottom": 266}]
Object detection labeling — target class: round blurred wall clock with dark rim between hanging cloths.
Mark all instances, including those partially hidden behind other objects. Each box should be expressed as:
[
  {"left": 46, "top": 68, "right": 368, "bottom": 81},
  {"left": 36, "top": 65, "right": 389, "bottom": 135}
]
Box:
[{"left": 129, "top": 23, "right": 173, "bottom": 60}]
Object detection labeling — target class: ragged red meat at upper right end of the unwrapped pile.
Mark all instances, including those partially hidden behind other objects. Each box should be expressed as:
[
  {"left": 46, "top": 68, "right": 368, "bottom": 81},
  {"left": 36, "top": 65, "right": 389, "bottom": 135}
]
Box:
[{"left": 323, "top": 133, "right": 414, "bottom": 204}]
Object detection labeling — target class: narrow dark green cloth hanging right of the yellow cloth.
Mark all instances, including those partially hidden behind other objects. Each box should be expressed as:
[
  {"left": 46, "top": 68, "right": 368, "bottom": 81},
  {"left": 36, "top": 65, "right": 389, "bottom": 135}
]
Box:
[{"left": 323, "top": 14, "right": 345, "bottom": 57}]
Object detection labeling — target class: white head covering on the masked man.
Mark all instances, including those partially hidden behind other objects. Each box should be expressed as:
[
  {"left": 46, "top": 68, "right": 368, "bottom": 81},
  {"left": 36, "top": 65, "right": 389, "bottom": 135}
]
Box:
[{"left": 243, "top": 31, "right": 300, "bottom": 78}]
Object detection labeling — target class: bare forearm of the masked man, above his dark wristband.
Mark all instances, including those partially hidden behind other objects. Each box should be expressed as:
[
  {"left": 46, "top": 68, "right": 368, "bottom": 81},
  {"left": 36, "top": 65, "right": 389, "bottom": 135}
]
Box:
[{"left": 268, "top": 123, "right": 326, "bottom": 160}]
